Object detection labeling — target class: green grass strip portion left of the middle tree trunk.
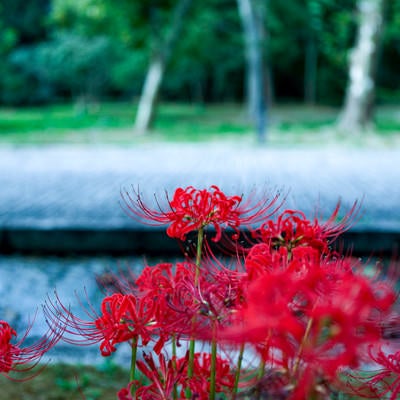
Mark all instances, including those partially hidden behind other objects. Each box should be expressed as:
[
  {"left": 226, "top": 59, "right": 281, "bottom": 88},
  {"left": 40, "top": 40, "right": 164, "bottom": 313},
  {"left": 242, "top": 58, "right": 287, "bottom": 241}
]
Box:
[{"left": 0, "top": 103, "right": 249, "bottom": 144}]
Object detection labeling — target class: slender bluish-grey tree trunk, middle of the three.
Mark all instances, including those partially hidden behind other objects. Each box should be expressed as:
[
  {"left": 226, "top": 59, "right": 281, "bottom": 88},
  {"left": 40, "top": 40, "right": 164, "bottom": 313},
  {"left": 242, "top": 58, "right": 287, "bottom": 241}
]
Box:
[{"left": 237, "top": 0, "right": 267, "bottom": 143}]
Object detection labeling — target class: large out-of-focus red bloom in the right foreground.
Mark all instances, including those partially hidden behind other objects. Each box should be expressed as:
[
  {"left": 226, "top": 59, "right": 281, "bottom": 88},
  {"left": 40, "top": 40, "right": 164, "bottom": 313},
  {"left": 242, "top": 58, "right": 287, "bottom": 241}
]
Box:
[{"left": 235, "top": 252, "right": 395, "bottom": 387}]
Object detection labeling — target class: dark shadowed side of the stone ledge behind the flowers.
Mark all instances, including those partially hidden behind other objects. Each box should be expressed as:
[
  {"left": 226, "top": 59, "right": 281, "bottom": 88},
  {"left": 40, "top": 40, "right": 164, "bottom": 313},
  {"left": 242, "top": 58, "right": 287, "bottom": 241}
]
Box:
[{"left": 0, "top": 228, "right": 400, "bottom": 256}]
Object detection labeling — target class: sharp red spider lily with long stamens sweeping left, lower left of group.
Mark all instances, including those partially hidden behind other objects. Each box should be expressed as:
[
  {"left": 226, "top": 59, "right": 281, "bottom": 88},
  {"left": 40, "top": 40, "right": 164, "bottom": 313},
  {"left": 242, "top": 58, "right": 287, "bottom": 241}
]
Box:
[{"left": 44, "top": 293, "right": 157, "bottom": 356}]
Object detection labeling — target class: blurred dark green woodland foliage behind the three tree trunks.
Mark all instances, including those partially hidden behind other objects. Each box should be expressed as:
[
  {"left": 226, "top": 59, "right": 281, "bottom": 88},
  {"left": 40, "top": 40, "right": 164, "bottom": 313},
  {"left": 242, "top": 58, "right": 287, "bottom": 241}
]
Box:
[{"left": 0, "top": 0, "right": 400, "bottom": 133}]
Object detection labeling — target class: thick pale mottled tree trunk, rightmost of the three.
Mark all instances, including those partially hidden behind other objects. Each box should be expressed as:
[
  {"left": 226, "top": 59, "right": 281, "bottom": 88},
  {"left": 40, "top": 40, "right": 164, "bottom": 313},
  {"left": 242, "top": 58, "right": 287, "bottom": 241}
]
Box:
[{"left": 338, "top": 0, "right": 384, "bottom": 133}]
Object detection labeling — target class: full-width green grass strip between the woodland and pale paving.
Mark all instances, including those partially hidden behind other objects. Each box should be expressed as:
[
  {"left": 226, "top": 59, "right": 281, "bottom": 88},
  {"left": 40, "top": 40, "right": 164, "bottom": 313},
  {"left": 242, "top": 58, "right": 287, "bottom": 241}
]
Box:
[{"left": 0, "top": 102, "right": 400, "bottom": 146}]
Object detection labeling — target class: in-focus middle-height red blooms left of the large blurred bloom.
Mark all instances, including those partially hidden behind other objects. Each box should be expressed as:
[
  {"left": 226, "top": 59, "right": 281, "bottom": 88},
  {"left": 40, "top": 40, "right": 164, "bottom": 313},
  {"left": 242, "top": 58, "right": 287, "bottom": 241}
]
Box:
[{"left": 45, "top": 262, "right": 244, "bottom": 350}]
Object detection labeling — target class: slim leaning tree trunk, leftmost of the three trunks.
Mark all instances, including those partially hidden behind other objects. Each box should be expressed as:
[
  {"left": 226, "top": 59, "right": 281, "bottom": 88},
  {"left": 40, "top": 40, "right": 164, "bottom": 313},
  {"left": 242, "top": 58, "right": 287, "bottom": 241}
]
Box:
[{"left": 135, "top": 0, "right": 192, "bottom": 133}]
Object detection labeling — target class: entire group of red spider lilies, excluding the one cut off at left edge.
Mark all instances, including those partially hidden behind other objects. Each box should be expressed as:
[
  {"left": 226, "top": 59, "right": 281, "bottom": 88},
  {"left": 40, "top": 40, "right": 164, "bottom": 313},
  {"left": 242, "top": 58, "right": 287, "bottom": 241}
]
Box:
[{"left": 45, "top": 186, "right": 400, "bottom": 400}]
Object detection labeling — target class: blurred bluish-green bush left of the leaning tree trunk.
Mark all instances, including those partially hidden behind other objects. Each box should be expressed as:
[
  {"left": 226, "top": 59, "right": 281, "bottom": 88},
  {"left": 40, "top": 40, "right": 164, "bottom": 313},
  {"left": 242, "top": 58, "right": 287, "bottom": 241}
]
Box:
[{"left": 3, "top": 33, "right": 116, "bottom": 104}]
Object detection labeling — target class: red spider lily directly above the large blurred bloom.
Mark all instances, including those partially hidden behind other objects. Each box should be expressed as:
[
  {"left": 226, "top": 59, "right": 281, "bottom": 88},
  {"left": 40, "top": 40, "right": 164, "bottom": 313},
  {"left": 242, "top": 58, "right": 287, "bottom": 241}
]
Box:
[{"left": 253, "top": 203, "right": 357, "bottom": 254}]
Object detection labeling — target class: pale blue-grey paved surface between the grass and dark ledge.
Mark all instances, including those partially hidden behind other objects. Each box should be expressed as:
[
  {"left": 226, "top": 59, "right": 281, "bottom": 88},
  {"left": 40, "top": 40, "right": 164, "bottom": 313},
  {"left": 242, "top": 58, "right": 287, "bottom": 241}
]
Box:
[{"left": 0, "top": 143, "right": 400, "bottom": 251}]
